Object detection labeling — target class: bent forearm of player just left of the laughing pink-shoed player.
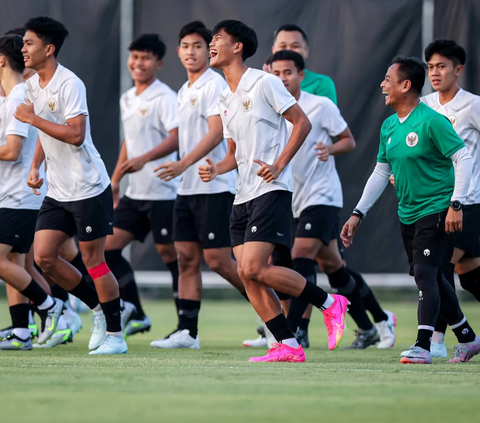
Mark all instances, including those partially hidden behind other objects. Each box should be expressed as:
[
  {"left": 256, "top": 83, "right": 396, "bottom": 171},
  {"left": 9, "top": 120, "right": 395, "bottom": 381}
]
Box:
[{"left": 155, "top": 115, "right": 223, "bottom": 181}]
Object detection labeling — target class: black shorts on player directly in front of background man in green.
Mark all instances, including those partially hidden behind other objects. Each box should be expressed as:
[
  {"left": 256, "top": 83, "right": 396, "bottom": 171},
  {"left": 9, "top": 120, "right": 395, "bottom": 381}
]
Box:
[{"left": 294, "top": 205, "right": 341, "bottom": 245}]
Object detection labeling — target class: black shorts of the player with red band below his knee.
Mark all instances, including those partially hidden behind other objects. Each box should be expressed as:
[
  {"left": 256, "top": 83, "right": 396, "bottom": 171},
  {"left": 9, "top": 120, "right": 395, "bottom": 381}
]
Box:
[{"left": 35, "top": 185, "right": 113, "bottom": 242}]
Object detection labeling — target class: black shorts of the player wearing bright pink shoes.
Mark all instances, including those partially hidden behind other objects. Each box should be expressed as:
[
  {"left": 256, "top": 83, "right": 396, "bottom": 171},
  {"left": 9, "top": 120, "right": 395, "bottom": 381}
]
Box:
[{"left": 230, "top": 191, "right": 292, "bottom": 248}]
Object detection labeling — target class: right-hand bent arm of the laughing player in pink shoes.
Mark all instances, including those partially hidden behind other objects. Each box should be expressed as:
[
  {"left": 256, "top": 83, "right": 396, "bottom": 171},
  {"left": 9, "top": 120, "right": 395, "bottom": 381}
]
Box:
[{"left": 254, "top": 104, "right": 312, "bottom": 182}]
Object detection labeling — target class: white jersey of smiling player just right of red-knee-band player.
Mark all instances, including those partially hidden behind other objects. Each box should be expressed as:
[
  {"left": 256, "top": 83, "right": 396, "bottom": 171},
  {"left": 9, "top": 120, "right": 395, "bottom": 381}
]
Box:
[{"left": 120, "top": 79, "right": 179, "bottom": 201}]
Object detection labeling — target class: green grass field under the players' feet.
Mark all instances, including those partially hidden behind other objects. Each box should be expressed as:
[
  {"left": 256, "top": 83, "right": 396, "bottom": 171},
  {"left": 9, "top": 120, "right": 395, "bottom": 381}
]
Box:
[{"left": 0, "top": 300, "right": 480, "bottom": 423}]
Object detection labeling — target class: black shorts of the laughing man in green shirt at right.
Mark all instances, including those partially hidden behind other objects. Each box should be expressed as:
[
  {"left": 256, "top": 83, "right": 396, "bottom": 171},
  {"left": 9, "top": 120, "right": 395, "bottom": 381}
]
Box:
[{"left": 400, "top": 210, "right": 453, "bottom": 274}]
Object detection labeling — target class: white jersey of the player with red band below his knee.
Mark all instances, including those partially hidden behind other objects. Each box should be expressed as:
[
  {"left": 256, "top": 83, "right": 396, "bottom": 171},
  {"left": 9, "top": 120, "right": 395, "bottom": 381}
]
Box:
[{"left": 25, "top": 64, "right": 110, "bottom": 202}]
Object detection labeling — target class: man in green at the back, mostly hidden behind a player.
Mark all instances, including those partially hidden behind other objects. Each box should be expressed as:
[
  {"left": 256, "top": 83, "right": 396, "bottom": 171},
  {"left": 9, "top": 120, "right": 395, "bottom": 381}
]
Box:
[{"left": 272, "top": 24, "right": 337, "bottom": 104}]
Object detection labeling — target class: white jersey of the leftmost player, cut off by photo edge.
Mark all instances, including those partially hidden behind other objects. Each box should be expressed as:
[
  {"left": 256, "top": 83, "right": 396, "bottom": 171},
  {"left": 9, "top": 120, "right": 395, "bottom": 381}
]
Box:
[{"left": 0, "top": 82, "right": 45, "bottom": 210}]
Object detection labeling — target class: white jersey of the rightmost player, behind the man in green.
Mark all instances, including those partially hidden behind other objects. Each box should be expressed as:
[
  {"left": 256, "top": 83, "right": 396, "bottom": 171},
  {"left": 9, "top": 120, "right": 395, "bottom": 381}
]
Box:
[{"left": 422, "top": 89, "right": 480, "bottom": 204}]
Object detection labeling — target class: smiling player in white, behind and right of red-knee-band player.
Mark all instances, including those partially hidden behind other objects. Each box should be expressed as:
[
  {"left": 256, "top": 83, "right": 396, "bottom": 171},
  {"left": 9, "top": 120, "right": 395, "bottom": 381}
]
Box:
[{"left": 105, "top": 34, "right": 178, "bottom": 336}]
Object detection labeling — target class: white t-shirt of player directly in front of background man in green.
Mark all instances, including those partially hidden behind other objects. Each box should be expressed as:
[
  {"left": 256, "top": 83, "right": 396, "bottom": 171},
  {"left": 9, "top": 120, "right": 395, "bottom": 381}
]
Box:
[{"left": 287, "top": 91, "right": 348, "bottom": 218}]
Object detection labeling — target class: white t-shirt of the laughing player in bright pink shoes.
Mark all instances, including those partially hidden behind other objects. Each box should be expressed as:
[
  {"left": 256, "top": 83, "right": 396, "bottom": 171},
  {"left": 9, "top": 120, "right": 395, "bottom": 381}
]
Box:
[{"left": 218, "top": 68, "right": 297, "bottom": 204}]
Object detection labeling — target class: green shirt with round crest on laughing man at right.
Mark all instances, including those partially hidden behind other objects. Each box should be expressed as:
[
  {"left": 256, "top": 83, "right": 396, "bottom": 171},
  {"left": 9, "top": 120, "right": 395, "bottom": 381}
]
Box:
[{"left": 377, "top": 103, "right": 465, "bottom": 225}]
